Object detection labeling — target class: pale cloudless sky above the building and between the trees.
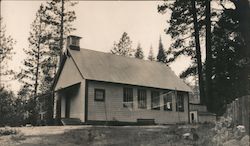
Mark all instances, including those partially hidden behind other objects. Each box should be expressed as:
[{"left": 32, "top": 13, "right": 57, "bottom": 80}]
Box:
[{"left": 1, "top": 0, "right": 190, "bottom": 91}]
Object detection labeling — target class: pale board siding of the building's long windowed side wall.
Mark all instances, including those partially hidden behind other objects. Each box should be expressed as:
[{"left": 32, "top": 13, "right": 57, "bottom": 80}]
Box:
[{"left": 88, "top": 81, "right": 189, "bottom": 124}]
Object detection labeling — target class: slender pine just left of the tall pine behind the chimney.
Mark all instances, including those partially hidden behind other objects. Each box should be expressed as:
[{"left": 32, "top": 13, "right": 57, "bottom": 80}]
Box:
[{"left": 17, "top": 5, "right": 47, "bottom": 124}]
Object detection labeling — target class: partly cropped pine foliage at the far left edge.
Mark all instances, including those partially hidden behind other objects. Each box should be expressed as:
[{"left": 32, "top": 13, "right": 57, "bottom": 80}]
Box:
[{"left": 0, "top": 17, "right": 15, "bottom": 87}]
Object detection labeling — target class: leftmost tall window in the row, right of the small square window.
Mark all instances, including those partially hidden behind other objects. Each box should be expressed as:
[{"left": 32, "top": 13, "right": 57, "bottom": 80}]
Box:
[{"left": 123, "top": 88, "right": 133, "bottom": 108}]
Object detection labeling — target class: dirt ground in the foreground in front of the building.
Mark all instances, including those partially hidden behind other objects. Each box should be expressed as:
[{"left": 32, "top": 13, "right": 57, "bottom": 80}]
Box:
[{"left": 0, "top": 125, "right": 213, "bottom": 146}]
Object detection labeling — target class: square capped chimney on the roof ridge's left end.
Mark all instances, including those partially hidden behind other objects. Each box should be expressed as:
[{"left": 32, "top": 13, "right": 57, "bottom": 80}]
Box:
[{"left": 67, "top": 35, "right": 81, "bottom": 51}]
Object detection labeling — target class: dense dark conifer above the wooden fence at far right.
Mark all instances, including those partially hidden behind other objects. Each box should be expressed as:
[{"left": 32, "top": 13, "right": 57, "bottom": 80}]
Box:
[{"left": 208, "top": 1, "right": 250, "bottom": 115}]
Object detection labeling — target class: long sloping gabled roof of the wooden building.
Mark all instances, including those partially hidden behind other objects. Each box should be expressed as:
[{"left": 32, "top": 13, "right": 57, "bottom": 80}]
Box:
[{"left": 68, "top": 49, "right": 191, "bottom": 92}]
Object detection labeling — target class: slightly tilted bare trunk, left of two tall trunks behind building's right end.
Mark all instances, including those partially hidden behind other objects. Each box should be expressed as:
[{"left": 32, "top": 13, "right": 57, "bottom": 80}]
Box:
[{"left": 192, "top": 0, "right": 205, "bottom": 104}]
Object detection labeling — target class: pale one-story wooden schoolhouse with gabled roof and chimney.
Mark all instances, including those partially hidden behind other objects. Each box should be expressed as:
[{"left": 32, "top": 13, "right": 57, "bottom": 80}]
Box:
[{"left": 53, "top": 36, "right": 192, "bottom": 124}]
